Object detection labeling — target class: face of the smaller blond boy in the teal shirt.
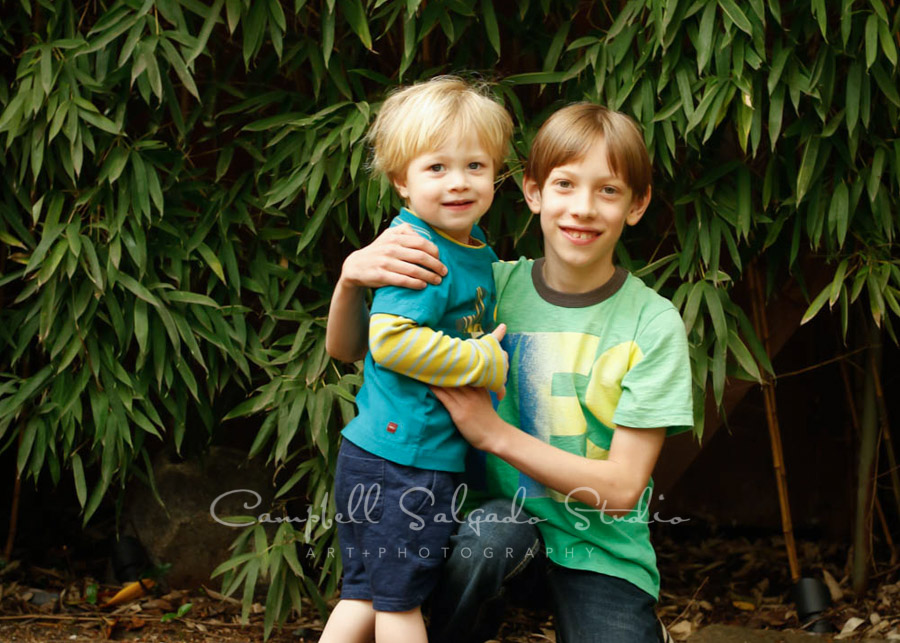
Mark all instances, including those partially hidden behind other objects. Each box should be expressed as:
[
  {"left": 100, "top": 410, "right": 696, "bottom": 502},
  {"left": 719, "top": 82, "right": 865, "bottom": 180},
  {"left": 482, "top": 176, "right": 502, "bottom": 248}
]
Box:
[{"left": 394, "top": 134, "right": 494, "bottom": 243}]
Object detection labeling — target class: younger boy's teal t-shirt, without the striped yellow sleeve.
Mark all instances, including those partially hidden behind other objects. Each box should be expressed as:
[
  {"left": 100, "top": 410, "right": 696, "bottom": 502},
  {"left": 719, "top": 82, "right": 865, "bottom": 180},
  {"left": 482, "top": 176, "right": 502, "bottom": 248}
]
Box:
[{"left": 343, "top": 208, "right": 497, "bottom": 472}]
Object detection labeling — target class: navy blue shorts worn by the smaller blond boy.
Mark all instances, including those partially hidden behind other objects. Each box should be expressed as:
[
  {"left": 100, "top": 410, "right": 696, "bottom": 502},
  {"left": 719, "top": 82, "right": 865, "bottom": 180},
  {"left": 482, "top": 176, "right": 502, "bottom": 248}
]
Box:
[{"left": 334, "top": 439, "right": 457, "bottom": 612}]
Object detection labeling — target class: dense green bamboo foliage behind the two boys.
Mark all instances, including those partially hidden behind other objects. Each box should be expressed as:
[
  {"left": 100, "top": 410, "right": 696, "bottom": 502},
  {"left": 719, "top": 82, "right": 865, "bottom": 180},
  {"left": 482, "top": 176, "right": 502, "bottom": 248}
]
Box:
[{"left": 0, "top": 0, "right": 900, "bottom": 628}]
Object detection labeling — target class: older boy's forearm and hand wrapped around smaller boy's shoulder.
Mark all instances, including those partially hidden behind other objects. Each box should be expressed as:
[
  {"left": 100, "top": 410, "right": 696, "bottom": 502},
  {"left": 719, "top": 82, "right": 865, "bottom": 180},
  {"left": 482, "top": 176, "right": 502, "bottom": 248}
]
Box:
[{"left": 325, "top": 223, "right": 447, "bottom": 362}]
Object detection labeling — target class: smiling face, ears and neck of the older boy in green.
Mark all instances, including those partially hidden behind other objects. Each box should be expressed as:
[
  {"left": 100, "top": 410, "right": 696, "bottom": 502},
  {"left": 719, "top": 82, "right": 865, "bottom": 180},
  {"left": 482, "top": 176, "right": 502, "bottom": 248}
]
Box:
[{"left": 522, "top": 137, "right": 650, "bottom": 293}]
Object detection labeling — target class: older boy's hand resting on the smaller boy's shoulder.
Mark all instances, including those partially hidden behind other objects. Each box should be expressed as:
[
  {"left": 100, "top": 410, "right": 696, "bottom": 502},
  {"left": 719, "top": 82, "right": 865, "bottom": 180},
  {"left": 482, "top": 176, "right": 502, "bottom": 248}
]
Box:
[{"left": 341, "top": 223, "right": 447, "bottom": 290}]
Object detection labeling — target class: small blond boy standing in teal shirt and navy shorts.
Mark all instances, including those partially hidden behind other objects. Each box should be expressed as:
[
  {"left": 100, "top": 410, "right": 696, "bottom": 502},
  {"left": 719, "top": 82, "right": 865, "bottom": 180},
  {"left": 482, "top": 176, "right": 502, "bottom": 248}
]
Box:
[{"left": 321, "top": 77, "right": 512, "bottom": 643}]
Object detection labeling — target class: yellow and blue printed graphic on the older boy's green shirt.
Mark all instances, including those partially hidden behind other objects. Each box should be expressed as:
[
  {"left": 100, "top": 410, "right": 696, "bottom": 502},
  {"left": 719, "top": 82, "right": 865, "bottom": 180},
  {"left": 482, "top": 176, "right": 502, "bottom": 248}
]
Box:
[{"left": 500, "top": 332, "right": 643, "bottom": 501}]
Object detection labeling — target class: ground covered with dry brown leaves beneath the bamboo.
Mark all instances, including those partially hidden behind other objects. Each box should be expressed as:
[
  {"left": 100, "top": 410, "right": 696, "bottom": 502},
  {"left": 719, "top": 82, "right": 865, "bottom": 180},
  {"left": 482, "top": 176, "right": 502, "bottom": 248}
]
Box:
[{"left": 0, "top": 537, "right": 900, "bottom": 643}]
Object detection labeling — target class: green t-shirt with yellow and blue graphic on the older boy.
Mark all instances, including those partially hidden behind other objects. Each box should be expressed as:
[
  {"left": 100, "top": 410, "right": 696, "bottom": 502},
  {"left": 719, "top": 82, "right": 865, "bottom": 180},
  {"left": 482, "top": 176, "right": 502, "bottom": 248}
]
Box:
[{"left": 468, "top": 259, "right": 693, "bottom": 597}]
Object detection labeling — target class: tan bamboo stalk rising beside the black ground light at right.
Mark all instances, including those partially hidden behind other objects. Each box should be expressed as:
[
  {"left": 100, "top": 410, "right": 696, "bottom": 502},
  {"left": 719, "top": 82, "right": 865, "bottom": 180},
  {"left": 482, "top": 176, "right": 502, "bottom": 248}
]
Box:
[{"left": 747, "top": 265, "right": 800, "bottom": 583}]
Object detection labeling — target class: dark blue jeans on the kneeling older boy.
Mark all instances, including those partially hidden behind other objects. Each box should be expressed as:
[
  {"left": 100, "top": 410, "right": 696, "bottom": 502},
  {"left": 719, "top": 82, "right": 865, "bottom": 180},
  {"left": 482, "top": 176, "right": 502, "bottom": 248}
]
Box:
[{"left": 428, "top": 500, "right": 659, "bottom": 643}]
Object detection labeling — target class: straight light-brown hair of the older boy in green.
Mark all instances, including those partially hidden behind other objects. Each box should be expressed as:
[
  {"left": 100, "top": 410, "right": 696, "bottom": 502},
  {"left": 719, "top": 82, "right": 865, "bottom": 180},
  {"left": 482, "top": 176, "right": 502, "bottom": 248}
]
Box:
[{"left": 525, "top": 103, "right": 653, "bottom": 198}]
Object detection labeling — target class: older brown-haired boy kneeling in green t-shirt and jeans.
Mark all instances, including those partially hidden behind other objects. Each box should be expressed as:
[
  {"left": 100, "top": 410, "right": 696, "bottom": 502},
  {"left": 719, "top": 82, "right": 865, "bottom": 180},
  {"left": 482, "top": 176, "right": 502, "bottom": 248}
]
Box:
[{"left": 329, "top": 103, "right": 693, "bottom": 643}]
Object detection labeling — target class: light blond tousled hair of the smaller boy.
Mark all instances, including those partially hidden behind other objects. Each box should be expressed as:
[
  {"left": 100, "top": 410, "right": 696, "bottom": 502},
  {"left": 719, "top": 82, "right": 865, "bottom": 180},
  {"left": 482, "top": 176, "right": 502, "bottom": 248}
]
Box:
[{"left": 368, "top": 76, "right": 513, "bottom": 181}]
